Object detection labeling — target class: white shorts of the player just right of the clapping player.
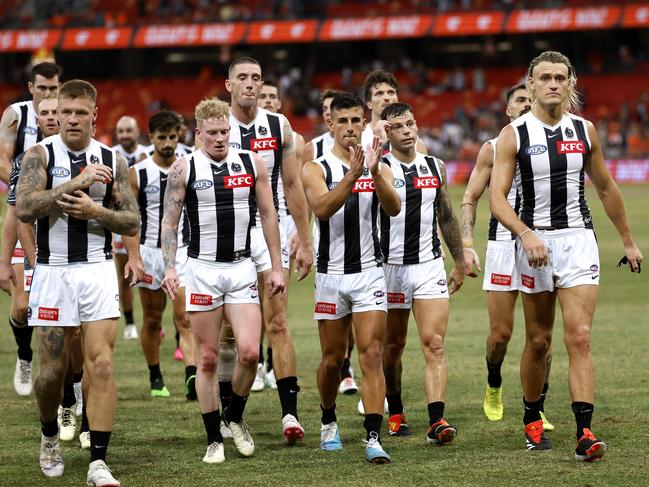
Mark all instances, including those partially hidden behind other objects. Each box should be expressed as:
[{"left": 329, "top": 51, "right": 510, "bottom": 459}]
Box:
[{"left": 384, "top": 259, "right": 448, "bottom": 309}]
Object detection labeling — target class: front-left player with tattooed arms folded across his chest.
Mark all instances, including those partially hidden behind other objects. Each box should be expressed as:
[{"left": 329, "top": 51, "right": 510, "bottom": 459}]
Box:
[{"left": 16, "top": 80, "right": 139, "bottom": 485}]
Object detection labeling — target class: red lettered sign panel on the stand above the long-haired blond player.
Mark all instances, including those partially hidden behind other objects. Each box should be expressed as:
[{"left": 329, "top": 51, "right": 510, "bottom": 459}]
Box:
[{"left": 505, "top": 7, "right": 622, "bottom": 33}]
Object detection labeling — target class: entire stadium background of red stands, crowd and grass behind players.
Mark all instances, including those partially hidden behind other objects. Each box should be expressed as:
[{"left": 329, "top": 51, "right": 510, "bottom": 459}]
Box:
[{"left": 0, "top": 0, "right": 649, "bottom": 485}]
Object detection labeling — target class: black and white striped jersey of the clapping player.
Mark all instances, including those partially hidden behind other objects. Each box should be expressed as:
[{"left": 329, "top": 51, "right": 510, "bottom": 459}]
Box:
[{"left": 313, "top": 152, "right": 383, "bottom": 274}]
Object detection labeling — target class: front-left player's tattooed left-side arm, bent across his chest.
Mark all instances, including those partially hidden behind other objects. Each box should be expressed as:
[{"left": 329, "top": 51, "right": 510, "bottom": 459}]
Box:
[{"left": 16, "top": 145, "right": 114, "bottom": 222}]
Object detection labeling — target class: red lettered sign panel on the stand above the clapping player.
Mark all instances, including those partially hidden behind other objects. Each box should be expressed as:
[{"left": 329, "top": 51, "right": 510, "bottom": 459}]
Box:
[{"left": 319, "top": 15, "right": 433, "bottom": 41}]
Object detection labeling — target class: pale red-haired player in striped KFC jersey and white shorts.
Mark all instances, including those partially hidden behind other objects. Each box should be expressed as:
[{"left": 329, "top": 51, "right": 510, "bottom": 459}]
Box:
[{"left": 162, "top": 98, "right": 284, "bottom": 463}]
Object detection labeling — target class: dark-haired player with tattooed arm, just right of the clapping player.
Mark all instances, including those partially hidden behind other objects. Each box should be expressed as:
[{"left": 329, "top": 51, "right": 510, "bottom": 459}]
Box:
[{"left": 380, "top": 103, "right": 465, "bottom": 445}]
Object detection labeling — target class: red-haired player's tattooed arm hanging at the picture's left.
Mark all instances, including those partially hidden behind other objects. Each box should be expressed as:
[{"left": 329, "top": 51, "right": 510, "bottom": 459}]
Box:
[{"left": 160, "top": 157, "right": 187, "bottom": 299}]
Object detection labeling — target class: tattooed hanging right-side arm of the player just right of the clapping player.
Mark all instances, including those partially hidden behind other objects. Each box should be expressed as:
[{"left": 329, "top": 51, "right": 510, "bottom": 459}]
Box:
[{"left": 437, "top": 161, "right": 465, "bottom": 294}]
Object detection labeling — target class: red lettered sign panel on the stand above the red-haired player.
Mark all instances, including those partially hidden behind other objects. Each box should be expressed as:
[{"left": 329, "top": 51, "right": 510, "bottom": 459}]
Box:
[{"left": 133, "top": 22, "right": 246, "bottom": 47}]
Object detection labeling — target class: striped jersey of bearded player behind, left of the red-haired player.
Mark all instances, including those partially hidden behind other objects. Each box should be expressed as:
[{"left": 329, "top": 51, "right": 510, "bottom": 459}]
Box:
[{"left": 133, "top": 157, "right": 189, "bottom": 248}]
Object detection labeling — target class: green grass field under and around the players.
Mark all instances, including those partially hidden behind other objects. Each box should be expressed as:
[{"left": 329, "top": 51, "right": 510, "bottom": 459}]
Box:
[{"left": 0, "top": 186, "right": 649, "bottom": 487}]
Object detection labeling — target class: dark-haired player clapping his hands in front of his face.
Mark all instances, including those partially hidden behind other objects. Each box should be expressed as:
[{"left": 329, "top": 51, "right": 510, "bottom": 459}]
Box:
[{"left": 302, "top": 94, "right": 401, "bottom": 463}]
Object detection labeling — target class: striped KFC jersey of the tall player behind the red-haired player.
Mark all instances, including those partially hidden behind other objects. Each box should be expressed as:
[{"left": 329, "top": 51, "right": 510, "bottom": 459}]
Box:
[{"left": 230, "top": 108, "right": 286, "bottom": 226}]
